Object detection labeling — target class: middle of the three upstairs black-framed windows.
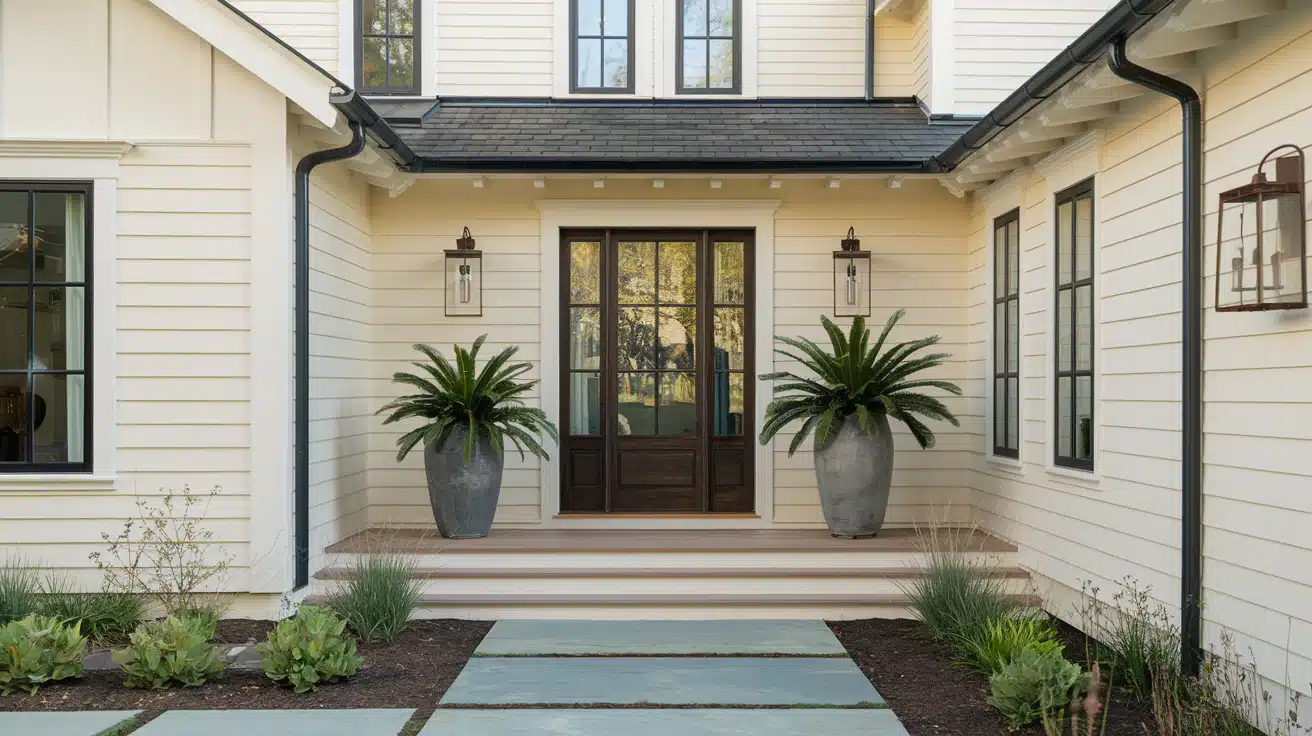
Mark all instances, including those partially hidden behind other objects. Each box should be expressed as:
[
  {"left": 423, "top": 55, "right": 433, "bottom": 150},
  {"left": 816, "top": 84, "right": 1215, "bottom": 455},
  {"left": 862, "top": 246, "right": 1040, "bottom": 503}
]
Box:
[{"left": 569, "top": 0, "right": 634, "bottom": 94}]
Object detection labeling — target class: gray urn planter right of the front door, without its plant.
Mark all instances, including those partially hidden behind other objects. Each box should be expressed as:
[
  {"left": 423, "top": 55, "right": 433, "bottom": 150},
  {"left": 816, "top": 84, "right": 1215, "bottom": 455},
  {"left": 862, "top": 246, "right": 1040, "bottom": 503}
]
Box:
[{"left": 816, "top": 416, "right": 893, "bottom": 539}]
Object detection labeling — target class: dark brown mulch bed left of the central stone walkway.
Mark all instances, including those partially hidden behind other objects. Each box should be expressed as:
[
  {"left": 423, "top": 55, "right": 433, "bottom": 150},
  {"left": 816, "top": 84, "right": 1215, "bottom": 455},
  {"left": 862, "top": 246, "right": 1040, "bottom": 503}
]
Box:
[{"left": 0, "top": 619, "right": 492, "bottom": 720}]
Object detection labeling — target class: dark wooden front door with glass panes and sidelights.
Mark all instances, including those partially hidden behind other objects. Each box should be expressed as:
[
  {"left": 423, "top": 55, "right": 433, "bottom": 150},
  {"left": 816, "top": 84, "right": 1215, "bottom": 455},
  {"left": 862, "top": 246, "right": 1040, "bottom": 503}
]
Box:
[{"left": 560, "top": 230, "right": 754, "bottom": 513}]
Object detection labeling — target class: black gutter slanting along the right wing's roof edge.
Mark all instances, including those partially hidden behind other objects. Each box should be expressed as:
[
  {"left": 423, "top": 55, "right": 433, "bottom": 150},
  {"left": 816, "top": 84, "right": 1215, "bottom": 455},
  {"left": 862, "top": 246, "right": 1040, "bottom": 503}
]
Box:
[{"left": 934, "top": 0, "right": 1176, "bottom": 173}]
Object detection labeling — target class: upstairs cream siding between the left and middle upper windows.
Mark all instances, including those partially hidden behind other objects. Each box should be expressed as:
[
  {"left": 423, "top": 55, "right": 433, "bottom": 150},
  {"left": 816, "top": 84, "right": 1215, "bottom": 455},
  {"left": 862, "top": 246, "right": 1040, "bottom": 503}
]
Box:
[{"left": 422, "top": 0, "right": 551, "bottom": 97}]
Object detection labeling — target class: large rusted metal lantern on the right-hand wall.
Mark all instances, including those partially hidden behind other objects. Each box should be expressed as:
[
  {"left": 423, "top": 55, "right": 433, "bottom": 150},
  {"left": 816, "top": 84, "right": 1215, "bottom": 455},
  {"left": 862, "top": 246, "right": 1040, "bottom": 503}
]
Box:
[{"left": 1216, "top": 144, "right": 1308, "bottom": 312}]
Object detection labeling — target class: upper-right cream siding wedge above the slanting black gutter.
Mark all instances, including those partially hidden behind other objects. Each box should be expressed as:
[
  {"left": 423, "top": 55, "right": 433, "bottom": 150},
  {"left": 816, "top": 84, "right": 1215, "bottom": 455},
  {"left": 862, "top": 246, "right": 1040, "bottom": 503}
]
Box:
[{"left": 949, "top": 0, "right": 1115, "bottom": 115}]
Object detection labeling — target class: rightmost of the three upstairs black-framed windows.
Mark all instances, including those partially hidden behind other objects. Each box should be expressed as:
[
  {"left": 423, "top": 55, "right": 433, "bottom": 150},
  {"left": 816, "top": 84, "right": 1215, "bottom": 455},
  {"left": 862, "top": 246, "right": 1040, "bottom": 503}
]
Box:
[{"left": 676, "top": 0, "right": 743, "bottom": 94}]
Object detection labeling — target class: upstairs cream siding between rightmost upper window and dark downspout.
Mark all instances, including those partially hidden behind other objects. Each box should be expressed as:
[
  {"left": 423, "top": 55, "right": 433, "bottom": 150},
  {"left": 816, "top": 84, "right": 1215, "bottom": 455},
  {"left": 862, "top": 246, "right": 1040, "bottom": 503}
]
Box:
[{"left": 757, "top": 0, "right": 866, "bottom": 97}]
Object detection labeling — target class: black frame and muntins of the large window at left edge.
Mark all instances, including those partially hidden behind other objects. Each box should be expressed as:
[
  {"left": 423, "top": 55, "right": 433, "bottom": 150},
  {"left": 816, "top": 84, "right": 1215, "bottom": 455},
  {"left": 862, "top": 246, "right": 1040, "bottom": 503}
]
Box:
[{"left": 0, "top": 180, "right": 96, "bottom": 479}]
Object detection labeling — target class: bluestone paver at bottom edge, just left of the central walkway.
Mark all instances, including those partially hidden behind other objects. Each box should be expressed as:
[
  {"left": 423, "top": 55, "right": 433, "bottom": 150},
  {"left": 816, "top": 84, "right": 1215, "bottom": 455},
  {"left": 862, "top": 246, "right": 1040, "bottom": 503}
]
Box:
[{"left": 133, "top": 708, "right": 415, "bottom": 736}]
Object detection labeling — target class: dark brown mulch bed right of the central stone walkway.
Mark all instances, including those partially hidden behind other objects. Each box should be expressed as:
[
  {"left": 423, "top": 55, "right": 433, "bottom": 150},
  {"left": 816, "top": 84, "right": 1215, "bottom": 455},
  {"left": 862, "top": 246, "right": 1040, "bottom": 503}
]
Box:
[{"left": 829, "top": 619, "right": 1153, "bottom": 736}]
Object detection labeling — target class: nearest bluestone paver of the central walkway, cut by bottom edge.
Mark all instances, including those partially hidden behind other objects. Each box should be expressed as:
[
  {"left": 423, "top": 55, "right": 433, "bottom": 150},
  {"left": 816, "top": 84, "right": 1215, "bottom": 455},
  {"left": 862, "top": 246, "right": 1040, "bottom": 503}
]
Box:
[{"left": 420, "top": 708, "right": 907, "bottom": 736}]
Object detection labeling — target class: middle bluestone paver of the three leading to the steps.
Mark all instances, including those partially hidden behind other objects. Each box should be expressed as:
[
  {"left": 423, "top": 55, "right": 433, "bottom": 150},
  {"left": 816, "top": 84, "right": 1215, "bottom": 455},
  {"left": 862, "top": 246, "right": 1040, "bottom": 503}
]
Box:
[{"left": 442, "top": 657, "right": 883, "bottom": 707}]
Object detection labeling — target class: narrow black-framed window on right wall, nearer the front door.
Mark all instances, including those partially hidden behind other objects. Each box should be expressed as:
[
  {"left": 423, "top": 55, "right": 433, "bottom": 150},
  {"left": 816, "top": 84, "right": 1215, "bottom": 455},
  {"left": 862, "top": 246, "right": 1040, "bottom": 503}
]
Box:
[{"left": 993, "top": 209, "right": 1021, "bottom": 458}]
